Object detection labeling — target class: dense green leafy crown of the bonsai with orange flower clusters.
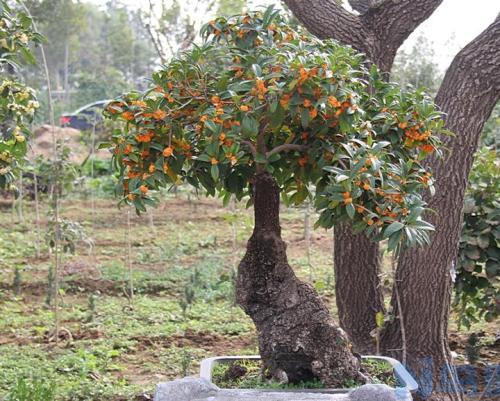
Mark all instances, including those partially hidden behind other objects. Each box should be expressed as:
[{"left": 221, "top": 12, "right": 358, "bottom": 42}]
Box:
[{"left": 107, "top": 8, "right": 443, "bottom": 247}]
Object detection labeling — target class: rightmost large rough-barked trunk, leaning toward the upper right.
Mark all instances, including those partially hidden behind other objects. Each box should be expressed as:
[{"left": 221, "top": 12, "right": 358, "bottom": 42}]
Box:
[{"left": 382, "top": 17, "right": 500, "bottom": 400}]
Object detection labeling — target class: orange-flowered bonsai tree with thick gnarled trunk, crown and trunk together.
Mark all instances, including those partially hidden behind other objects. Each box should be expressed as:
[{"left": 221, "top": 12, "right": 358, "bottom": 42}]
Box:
[{"left": 106, "top": 9, "right": 443, "bottom": 386}]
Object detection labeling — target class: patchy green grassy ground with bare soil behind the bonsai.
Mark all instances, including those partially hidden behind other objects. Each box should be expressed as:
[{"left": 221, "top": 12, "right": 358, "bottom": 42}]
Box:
[{"left": 0, "top": 193, "right": 498, "bottom": 401}]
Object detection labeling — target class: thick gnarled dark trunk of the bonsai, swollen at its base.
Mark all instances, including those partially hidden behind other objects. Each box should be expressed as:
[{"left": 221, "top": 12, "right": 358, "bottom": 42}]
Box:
[{"left": 237, "top": 173, "right": 362, "bottom": 387}]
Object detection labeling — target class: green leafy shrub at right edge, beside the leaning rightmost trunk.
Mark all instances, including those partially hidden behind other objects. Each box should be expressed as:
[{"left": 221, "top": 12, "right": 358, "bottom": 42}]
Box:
[{"left": 455, "top": 146, "right": 500, "bottom": 327}]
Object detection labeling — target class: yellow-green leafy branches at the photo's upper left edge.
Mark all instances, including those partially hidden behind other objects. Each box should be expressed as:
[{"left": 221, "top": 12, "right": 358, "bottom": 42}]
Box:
[{"left": 0, "top": 0, "right": 42, "bottom": 189}]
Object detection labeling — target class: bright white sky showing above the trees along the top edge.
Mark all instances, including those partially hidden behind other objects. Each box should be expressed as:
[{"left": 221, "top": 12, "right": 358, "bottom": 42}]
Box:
[{"left": 85, "top": 0, "right": 500, "bottom": 70}]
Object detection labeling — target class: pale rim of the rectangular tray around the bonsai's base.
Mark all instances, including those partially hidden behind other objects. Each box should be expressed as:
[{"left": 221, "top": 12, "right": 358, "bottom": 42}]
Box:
[{"left": 200, "top": 355, "right": 418, "bottom": 394}]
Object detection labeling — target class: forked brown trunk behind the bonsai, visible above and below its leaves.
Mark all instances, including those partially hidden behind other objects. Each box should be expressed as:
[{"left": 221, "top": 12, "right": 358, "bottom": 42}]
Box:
[{"left": 285, "top": 0, "right": 442, "bottom": 354}]
